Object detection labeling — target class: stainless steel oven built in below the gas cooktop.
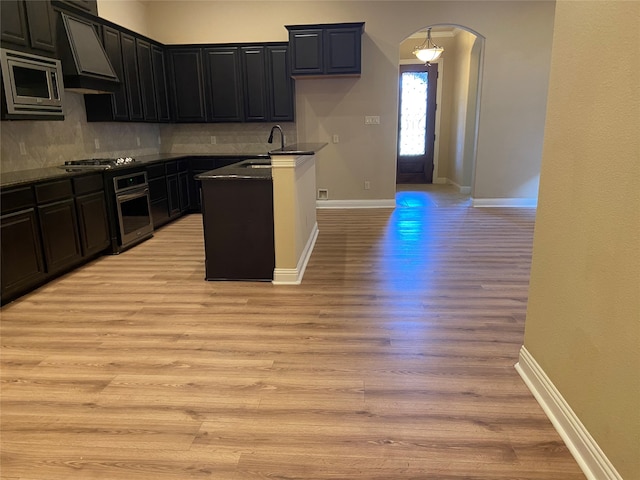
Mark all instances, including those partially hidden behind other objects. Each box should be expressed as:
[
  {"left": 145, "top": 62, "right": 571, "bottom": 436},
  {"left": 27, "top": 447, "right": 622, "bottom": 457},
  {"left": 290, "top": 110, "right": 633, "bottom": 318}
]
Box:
[{"left": 113, "top": 172, "right": 153, "bottom": 248}]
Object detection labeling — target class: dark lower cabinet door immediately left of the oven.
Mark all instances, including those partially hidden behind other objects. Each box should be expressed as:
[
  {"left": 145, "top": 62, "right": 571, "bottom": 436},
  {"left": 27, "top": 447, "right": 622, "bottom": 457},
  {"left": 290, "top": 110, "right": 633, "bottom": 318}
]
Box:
[{"left": 76, "top": 191, "right": 110, "bottom": 257}]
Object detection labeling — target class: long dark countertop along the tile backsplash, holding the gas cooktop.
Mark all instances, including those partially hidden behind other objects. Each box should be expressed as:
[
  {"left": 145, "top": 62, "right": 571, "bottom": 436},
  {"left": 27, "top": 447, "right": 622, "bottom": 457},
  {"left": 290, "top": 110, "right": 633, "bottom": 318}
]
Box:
[{"left": 0, "top": 152, "right": 271, "bottom": 188}]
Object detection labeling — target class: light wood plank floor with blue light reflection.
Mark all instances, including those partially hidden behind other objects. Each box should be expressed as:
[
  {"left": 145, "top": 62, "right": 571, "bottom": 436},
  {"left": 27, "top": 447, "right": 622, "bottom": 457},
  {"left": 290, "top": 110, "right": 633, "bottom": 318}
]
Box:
[{"left": 0, "top": 187, "right": 584, "bottom": 480}]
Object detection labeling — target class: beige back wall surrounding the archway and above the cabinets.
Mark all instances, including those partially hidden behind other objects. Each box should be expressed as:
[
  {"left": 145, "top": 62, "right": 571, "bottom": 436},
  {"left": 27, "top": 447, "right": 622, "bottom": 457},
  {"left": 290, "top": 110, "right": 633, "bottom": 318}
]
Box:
[{"left": 146, "top": 1, "right": 553, "bottom": 200}]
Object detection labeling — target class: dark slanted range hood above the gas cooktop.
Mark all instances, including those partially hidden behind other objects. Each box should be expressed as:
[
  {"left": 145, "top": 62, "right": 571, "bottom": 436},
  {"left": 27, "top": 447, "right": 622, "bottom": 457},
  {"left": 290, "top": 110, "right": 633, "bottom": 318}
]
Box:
[{"left": 57, "top": 12, "right": 120, "bottom": 93}]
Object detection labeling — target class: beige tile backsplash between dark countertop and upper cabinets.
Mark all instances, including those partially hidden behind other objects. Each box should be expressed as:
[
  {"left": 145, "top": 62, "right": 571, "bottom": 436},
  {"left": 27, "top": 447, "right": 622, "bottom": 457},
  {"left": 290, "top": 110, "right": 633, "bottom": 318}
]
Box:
[{"left": 0, "top": 92, "right": 297, "bottom": 172}]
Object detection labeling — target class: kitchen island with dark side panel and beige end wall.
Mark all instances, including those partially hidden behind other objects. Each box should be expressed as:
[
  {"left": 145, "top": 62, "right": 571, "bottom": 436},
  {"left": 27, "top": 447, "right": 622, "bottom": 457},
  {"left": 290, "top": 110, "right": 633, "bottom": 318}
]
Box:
[{"left": 196, "top": 143, "right": 326, "bottom": 284}]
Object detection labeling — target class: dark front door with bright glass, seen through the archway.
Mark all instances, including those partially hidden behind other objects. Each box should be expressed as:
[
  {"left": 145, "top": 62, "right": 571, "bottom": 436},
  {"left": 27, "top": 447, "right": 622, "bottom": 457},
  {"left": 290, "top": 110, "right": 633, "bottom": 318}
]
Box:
[{"left": 396, "top": 64, "right": 438, "bottom": 183}]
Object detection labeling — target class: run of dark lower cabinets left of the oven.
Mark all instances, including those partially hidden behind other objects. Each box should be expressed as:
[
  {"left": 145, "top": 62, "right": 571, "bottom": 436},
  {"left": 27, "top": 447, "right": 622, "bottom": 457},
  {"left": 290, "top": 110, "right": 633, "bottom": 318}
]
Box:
[{"left": 0, "top": 174, "right": 110, "bottom": 304}]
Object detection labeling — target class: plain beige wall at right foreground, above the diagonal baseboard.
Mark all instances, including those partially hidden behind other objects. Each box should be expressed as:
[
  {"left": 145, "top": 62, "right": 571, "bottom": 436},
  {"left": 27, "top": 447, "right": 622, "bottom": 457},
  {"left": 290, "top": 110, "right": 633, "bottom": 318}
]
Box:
[{"left": 525, "top": 0, "right": 640, "bottom": 480}]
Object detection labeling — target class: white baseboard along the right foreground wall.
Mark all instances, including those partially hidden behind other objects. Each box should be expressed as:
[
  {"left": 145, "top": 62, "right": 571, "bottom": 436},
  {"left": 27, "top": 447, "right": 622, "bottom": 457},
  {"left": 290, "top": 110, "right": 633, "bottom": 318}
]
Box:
[{"left": 516, "top": 345, "right": 622, "bottom": 480}]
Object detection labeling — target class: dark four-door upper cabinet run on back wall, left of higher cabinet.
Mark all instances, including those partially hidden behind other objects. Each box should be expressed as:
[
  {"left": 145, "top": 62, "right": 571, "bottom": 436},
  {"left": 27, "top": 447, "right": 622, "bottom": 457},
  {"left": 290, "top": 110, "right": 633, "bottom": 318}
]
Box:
[{"left": 168, "top": 42, "right": 295, "bottom": 123}]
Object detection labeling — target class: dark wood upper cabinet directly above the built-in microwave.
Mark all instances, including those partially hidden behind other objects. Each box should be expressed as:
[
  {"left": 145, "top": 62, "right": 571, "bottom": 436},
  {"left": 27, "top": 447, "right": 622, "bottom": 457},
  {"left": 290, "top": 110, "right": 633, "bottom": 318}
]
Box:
[{"left": 0, "top": 0, "right": 56, "bottom": 56}]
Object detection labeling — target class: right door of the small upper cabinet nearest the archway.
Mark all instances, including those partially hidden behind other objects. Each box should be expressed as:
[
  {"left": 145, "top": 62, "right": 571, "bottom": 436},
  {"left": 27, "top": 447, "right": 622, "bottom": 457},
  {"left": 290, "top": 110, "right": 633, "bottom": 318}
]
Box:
[{"left": 324, "top": 27, "right": 362, "bottom": 74}]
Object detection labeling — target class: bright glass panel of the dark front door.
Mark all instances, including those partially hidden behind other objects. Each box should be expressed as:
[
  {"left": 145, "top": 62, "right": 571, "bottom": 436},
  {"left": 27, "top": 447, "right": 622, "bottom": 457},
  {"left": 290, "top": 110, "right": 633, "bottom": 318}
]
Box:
[{"left": 399, "top": 72, "right": 429, "bottom": 156}]
